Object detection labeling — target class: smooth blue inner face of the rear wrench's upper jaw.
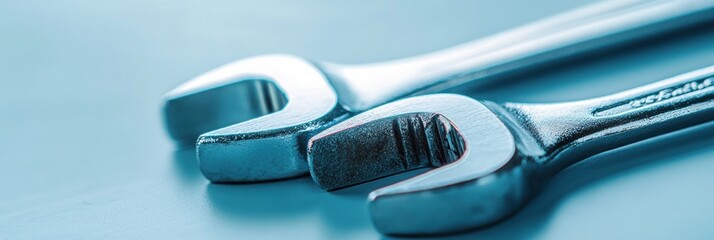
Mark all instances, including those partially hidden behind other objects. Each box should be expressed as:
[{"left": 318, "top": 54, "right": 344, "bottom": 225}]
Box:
[{"left": 164, "top": 78, "right": 288, "bottom": 147}]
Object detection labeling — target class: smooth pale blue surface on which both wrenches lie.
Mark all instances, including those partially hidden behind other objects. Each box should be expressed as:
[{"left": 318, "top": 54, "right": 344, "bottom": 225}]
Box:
[{"left": 0, "top": 0, "right": 714, "bottom": 239}]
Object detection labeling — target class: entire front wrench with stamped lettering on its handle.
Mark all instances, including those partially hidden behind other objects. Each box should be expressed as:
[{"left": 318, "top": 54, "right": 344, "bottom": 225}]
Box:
[{"left": 308, "top": 66, "right": 714, "bottom": 234}]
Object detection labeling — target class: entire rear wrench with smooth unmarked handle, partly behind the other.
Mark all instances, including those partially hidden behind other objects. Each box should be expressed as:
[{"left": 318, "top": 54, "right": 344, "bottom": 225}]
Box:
[{"left": 164, "top": 0, "right": 714, "bottom": 182}]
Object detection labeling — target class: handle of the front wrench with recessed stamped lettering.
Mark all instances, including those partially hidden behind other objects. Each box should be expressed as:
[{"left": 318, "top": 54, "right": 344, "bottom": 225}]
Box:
[{"left": 503, "top": 66, "right": 714, "bottom": 170}]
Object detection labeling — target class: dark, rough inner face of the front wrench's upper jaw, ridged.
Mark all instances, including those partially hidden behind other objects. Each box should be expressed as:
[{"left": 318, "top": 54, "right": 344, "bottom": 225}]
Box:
[{"left": 308, "top": 112, "right": 464, "bottom": 190}]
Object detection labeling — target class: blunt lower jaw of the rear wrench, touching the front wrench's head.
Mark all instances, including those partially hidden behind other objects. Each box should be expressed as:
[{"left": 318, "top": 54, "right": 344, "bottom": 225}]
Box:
[{"left": 196, "top": 104, "right": 348, "bottom": 183}]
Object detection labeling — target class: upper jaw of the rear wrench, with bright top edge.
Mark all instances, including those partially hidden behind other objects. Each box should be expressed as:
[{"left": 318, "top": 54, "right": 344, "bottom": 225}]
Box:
[{"left": 163, "top": 55, "right": 312, "bottom": 146}]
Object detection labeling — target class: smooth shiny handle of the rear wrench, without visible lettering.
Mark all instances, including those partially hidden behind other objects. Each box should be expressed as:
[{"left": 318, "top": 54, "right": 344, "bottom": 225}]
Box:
[{"left": 321, "top": 0, "right": 714, "bottom": 112}]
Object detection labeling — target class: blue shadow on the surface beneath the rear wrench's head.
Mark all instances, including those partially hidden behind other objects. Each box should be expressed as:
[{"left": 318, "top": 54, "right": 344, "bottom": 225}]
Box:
[{"left": 206, "top": 177, "right": 371, "bottom": 234}]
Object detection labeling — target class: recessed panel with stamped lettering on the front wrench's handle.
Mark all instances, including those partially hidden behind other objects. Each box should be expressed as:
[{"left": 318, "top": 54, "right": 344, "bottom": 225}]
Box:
[{"left": 593, "top": 77, "right": 714, "bottom": 116}]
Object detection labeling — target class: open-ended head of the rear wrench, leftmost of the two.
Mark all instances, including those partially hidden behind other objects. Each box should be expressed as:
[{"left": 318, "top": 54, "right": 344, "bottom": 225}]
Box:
[{"left": 164, "top": 55, "right": 346, "bottom": 182}]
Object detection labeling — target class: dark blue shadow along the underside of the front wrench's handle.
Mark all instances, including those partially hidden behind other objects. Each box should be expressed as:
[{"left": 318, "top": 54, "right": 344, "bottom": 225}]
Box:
[{"left": 383, "top": 123, "right": 714, "bottom": 239}]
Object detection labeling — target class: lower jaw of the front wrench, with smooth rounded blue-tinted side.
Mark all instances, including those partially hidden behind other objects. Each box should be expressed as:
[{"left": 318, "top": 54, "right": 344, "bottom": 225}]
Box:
[{"left": 368, "top": 155, "right": 532, "bottom": 236}]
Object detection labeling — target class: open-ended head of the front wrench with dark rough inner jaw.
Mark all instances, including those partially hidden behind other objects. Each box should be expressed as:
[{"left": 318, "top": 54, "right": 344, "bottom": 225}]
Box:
[{"left": 308, "top": 94, "right": 527, "bottom": 234}]
